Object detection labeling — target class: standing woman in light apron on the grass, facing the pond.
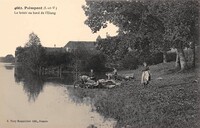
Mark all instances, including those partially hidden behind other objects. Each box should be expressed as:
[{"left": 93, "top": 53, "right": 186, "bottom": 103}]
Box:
[{"left": 141, "top": 62, "right": 151, "bottom": 85}]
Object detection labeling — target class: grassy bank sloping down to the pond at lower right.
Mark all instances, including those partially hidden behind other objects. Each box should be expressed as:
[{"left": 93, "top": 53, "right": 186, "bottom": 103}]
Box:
[{"left": 67, "top": 63, "right": 200, "bottom": 128}]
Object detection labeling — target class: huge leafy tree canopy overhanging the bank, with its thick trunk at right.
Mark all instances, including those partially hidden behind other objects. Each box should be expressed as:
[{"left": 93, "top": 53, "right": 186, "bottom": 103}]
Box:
[{"left": 83, "top": 0, "right": 199, "bottom": 70}]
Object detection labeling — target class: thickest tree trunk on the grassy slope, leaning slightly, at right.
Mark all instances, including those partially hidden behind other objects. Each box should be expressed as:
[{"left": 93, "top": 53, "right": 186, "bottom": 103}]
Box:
[{"left": 177, "top": 48, "right": 187, "bottom": 70}]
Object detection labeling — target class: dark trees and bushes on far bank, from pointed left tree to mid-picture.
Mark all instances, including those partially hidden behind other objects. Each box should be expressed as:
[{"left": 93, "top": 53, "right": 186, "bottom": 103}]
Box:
[{"left": 15, "top": 33, "right": 107, "bottom": 73}]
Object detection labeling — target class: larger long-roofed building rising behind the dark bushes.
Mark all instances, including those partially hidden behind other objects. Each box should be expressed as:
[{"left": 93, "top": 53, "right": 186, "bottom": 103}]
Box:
[{"left": 64, "top": 41, "right": 96, "bottom": 52}]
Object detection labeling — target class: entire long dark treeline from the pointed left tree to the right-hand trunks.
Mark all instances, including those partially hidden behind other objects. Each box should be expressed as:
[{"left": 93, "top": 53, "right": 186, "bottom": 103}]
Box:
[{"left": 15, "top": 33, "right": 176, "bottom": 73}]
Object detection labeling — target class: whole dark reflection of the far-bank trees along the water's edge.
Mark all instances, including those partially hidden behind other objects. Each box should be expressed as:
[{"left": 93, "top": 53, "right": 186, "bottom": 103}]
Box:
[{"left": 15, "top": 66, "right": 75, "bottom": 101}]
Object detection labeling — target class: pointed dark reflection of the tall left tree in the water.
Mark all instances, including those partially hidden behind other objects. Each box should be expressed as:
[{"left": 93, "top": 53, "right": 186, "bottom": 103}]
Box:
[{"left": 15, "top": 66, "right": 44, "bottom": 102}]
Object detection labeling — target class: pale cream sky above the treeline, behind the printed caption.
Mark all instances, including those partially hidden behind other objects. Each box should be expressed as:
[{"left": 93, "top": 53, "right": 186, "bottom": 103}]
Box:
[{"left": 0, "top": 0, "right": 118, "bottom": 56}]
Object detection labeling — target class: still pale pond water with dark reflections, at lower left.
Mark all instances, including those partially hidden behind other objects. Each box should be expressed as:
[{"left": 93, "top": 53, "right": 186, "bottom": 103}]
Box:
[{"left": 0, "top": 63, "right": 115, "bottom": 128}]
